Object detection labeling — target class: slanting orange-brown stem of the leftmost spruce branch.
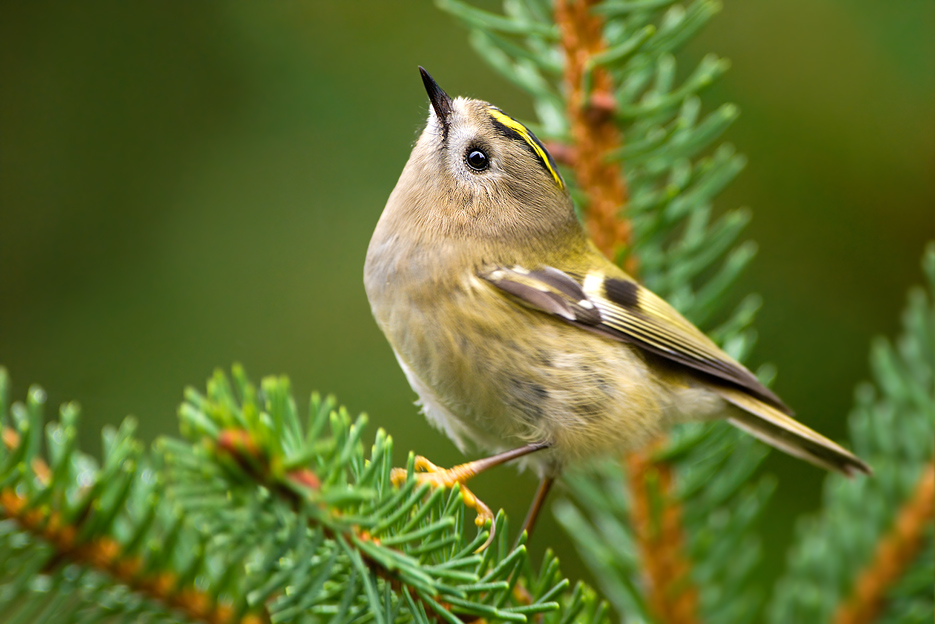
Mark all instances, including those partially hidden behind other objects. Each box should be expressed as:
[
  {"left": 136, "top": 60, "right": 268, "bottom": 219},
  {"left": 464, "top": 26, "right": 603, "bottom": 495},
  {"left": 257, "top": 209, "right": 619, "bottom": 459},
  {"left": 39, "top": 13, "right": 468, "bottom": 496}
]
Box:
[{"left": 0, "top": 427, "right": 269, "bottom": 624}]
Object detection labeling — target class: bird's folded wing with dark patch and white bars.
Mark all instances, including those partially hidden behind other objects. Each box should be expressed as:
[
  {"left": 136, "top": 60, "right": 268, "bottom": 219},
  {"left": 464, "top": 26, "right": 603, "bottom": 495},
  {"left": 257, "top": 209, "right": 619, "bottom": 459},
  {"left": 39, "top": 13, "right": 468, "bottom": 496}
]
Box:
[{"left": 479, "top": 266, "right": 792, "bottom": 414}]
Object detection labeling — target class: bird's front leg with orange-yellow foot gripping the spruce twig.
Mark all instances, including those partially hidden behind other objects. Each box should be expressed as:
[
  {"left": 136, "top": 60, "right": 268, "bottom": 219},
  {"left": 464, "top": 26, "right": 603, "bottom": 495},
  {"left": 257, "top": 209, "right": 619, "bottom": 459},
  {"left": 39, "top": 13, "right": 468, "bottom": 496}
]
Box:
[{"left": 390, "top": 442, "right": 551, "bottom": 551}]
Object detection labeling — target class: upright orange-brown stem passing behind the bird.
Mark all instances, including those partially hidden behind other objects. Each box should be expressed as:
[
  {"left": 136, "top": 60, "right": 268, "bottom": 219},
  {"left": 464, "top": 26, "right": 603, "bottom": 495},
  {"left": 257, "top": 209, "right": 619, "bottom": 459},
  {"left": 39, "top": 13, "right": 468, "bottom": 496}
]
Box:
[{"left": 555, "top": 0, "right": 698, "bottom": 624}]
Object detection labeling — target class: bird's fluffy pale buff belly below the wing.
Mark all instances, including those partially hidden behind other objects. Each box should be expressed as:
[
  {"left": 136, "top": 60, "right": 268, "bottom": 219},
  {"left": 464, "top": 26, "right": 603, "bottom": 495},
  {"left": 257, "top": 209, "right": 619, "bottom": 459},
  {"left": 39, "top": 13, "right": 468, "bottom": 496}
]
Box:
[{"left": 394, "top": 302, "right": 674, "bottom": 465}]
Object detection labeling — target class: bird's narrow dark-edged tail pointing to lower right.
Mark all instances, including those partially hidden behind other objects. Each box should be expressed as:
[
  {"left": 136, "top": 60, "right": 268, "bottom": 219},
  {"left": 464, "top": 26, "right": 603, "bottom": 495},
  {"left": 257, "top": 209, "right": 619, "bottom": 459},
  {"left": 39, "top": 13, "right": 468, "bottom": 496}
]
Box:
[{"left": 716, "top": 387, "right": 872, "bottom": 476}]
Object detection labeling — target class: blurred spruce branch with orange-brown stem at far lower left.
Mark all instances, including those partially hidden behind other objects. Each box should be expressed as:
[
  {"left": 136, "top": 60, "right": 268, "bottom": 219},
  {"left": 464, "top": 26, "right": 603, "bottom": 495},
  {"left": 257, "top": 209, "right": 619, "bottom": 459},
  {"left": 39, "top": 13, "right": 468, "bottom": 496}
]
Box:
[{"left": 0, "top": 376, "right": 268, "bottom": 624}]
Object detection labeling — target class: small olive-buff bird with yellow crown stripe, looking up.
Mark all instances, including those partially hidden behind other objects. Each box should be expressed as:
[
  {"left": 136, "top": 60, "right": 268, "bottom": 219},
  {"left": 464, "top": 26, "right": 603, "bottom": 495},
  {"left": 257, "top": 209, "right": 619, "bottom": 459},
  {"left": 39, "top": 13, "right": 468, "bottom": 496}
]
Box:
[{"left": 364, "top": 67, "right": 870, "bottom": 543}]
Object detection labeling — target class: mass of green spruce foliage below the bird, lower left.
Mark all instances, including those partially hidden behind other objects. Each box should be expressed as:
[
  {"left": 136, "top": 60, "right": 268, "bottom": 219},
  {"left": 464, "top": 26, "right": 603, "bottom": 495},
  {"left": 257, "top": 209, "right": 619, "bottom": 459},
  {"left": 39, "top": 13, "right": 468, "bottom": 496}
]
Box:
[{"left": 0, "top": 367, "right": 605, "bottom": 624}]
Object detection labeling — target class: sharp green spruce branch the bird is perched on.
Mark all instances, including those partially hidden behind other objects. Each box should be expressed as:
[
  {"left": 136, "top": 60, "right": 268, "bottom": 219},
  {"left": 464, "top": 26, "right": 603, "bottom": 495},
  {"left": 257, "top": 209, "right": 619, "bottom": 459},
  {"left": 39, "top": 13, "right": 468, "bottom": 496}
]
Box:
[{"left": 164, "top": 368, "right": 595, "bottom": 622}]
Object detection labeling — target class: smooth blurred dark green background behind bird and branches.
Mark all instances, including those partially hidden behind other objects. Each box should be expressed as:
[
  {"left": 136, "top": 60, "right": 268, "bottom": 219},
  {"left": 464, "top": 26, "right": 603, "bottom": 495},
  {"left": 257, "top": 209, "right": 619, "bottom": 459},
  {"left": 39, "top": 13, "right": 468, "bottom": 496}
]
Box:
[{"left": 0, "top": 0, "right": 935, "bottom": 596}]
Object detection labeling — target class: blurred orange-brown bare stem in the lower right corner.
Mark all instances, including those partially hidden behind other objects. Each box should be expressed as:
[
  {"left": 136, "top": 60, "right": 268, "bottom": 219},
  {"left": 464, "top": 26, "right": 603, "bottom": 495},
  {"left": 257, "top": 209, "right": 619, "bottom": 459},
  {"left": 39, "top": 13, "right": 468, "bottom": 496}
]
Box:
[{"left": 834, "top": 462, "right": 935, "bottom": 624}]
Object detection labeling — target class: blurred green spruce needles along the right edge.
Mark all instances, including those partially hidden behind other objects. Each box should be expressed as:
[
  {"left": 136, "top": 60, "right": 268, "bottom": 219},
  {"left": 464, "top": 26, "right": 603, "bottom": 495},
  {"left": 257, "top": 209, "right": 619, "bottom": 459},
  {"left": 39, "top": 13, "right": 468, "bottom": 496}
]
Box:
[{"left": 769, "top": 244, "right": 935, "bottom": 623}]
